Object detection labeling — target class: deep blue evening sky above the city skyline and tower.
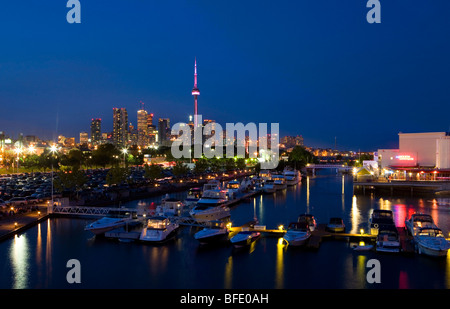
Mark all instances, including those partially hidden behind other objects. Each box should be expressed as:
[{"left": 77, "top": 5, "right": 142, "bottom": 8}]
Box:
[{"left": 0, "top": 0, "right": 450, "bottom": 150}]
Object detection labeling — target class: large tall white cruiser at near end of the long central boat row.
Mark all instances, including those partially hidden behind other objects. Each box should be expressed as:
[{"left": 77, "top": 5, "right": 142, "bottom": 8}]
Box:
[{"left": 189, "top": 190, "right": 230, "bottom": 222}]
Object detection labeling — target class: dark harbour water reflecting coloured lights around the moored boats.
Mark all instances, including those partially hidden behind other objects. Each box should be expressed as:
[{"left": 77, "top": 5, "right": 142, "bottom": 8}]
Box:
[{"left": 0, "top": 172, "right": 450, "bottom": 289}]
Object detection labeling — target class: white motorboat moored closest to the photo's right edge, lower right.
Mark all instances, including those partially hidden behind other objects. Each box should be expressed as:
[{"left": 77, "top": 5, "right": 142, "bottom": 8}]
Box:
[{"left": 414, "top": 227, "right": 450, "bottom": 257}]
